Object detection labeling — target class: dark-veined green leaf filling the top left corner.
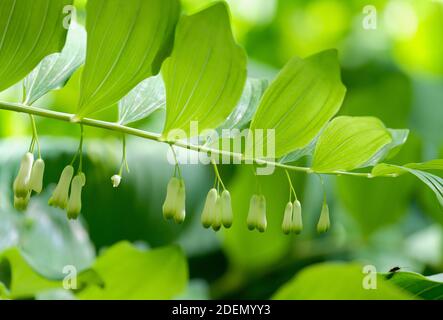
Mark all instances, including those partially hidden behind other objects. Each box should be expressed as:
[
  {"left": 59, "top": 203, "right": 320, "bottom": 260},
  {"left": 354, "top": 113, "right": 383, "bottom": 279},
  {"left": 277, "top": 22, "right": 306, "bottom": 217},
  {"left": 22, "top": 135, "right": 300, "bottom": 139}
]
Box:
[{"left": 0, "top": 0, "right": 72, "bottom": 91}]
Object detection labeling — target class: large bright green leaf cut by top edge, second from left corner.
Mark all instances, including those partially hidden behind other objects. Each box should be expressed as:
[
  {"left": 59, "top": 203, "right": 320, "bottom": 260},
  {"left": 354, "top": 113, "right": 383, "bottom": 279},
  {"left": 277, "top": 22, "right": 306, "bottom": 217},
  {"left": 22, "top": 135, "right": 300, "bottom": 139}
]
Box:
[{"left": 77, "top": 0, "right": 180, "bottom": 118}]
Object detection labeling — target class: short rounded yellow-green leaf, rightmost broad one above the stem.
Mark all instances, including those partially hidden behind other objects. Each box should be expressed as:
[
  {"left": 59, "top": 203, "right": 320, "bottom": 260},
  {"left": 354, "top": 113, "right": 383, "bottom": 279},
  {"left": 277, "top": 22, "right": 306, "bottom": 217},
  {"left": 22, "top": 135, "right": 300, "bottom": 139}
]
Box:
[{"left": 312, "top": 116, "right": 392, "bottom": 172}]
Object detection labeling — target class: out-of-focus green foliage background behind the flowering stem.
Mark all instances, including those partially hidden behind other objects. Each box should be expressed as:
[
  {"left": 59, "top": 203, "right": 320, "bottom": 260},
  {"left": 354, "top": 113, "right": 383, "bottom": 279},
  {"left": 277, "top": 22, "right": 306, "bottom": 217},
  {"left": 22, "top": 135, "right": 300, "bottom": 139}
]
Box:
[{"left": 0, "top": 0, "right": 443, "bottom": 299}]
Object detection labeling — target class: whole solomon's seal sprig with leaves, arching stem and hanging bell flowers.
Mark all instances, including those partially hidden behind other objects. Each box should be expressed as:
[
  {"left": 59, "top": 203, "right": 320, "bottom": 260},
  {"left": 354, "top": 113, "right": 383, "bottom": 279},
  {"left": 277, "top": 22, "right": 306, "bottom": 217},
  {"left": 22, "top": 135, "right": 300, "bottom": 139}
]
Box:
[{"left": 0, "top": 0, "right": 443, "bottom": 238}]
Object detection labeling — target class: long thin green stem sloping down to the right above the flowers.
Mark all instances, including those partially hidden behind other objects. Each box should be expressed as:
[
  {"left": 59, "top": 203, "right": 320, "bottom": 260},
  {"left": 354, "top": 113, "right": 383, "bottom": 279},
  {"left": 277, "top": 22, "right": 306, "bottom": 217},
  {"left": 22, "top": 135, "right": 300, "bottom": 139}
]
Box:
[{"left": 0, "top": 101, "right": 380, "bottom": 178}]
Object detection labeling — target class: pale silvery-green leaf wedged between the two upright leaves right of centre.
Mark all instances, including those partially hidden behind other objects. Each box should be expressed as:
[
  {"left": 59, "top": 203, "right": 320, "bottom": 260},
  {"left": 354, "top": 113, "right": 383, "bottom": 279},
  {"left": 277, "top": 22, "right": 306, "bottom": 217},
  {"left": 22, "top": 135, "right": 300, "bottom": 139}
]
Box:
[{"left": 220, "top": 78, "right": 268, "bottom": 129}]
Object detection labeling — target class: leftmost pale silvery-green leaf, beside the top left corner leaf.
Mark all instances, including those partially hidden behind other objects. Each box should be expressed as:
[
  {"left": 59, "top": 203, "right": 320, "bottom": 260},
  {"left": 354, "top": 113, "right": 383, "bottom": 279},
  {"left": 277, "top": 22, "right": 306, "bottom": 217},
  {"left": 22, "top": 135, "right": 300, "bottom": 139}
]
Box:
[{"left": 23, "top": 21, "right": 86, "bottom": 105}]
